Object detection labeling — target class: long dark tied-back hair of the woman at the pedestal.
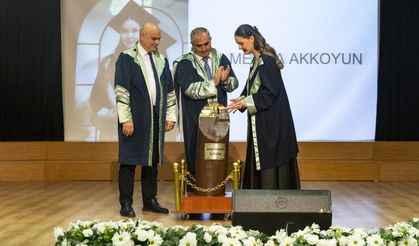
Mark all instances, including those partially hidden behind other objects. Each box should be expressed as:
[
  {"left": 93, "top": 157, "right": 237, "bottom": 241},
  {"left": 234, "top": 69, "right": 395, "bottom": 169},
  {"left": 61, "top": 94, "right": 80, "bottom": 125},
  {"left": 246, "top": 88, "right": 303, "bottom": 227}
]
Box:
[{"left": 234, "top": 24, "right": 284, "bottom": 69}]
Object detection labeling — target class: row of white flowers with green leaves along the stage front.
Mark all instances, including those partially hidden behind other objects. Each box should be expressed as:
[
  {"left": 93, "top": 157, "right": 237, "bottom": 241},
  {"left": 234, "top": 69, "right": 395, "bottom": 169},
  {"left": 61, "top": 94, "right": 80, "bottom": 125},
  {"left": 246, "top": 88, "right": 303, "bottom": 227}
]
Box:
[{"left": 54, "top": 218, "right": 419, "bottom": 246}]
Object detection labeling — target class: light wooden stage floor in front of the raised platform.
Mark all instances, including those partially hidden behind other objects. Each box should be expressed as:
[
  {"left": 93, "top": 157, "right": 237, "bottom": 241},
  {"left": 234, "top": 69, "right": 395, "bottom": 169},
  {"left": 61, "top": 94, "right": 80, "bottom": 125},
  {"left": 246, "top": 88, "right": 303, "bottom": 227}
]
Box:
[{"left": 0, "top": 181, "right": 419, "bottom": 245}]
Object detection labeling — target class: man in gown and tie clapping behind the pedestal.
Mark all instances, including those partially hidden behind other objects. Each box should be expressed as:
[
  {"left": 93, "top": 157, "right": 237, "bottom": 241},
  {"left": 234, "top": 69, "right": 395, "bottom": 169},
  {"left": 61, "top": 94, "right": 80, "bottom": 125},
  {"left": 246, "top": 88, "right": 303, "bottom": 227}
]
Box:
[{"left": 173, "top": 27, "right": 239, "bottom": 179}]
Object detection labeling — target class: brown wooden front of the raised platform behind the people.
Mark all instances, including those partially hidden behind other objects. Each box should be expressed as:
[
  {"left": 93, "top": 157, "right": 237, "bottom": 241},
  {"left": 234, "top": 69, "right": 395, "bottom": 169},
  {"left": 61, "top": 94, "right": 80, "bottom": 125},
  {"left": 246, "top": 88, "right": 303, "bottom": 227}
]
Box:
[{"left": 0, "top": 142, "right": 419, "bottom": 181}]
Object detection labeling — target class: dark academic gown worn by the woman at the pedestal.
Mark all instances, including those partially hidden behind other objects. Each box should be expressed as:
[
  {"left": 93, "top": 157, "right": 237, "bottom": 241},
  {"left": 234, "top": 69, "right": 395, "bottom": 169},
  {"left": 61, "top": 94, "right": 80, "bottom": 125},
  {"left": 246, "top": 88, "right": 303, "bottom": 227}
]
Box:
[{"left": 241, "top": 54, "right": 298, "bottom": 170}]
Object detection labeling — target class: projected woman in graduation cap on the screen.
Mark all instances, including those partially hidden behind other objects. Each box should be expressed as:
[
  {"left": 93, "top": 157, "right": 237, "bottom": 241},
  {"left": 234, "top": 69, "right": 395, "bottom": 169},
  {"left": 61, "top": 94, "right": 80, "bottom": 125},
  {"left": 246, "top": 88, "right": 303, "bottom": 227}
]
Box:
[{"left": 89, "top": 1, "right": 176, "bottom": 141}]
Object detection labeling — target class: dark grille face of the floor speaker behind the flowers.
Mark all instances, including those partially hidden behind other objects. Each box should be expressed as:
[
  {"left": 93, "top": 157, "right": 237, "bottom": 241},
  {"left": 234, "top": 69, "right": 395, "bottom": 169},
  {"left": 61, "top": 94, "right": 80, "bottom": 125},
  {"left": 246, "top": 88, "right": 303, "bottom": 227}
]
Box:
[{"left": 233, "top": 190, "right": 331, "bottom": 213}]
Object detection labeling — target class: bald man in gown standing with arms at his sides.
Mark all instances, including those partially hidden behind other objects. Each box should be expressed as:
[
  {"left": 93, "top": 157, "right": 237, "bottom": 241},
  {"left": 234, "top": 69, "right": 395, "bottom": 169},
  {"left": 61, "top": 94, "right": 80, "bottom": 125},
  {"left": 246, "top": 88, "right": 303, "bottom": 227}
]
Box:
[{"left": 115, "top": 22, "right": 176, "bottom": 217}]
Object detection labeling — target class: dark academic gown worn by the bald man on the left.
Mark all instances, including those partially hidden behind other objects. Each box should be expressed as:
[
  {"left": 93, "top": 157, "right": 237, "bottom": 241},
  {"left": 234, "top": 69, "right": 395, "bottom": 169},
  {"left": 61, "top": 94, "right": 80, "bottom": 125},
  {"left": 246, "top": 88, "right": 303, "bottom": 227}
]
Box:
[{"left": 115, "top": 48, "right": 176, "bottom": 166}]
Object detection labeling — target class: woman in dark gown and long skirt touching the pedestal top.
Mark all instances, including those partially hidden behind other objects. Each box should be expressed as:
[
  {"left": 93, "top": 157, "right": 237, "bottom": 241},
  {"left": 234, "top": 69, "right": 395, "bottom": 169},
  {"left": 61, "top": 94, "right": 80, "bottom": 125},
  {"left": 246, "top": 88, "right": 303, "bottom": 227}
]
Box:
[{"left": 228, "top": 24, "right": 300, "bottom": 189}]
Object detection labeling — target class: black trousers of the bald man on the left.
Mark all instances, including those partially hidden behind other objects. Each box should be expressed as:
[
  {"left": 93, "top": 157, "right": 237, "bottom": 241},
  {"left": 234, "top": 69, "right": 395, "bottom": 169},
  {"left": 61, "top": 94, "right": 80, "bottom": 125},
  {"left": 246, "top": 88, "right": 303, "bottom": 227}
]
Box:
[{"left": 119, "top": 107, "right": 159, "bottom": 205}]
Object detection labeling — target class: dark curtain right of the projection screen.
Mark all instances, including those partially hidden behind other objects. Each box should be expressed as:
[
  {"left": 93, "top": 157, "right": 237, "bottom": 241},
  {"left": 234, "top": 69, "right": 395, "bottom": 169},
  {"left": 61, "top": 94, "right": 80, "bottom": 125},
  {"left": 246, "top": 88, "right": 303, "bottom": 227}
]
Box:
[{"left": 375, "top": 0, "right": 419, "bottom": 141}]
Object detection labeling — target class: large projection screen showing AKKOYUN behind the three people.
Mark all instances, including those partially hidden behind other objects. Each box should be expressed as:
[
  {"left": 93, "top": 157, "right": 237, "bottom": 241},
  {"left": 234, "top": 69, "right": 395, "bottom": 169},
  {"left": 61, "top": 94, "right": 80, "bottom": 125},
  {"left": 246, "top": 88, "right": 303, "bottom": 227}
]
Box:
[{"left": 61, "top": 0, "right": 378, "bottom": 141}]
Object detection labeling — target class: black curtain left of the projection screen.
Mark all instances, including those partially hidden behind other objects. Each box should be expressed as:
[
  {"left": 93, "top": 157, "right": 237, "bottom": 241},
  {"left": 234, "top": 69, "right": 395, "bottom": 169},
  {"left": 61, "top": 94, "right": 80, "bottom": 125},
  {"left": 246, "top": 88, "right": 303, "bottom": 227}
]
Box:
[{"left": 0, "top": 0, "right": 64, "bottom": 141}]
